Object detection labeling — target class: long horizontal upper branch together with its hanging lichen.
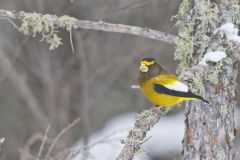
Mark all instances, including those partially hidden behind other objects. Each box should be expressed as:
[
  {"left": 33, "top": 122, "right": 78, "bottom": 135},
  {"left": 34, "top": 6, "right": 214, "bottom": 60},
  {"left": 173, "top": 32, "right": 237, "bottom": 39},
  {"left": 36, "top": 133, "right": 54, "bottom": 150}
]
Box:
[{"left": 0, "top": 9, "right": 177, "bottom": 50}]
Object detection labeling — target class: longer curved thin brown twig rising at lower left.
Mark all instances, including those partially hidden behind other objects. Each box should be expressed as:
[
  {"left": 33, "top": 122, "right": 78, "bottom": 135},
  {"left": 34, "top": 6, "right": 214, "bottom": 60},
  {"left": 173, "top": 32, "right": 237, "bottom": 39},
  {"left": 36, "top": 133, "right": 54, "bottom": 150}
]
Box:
[{"left": 45, "top": 118, "right": 80, "bottom": 160}]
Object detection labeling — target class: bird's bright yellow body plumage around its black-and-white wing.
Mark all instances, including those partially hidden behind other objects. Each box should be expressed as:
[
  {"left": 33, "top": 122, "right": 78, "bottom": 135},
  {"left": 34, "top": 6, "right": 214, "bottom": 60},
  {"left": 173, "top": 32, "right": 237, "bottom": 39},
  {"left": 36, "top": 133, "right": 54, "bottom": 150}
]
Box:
[{"left": 139, "top": 77, "right": 189, "bottom": 107}]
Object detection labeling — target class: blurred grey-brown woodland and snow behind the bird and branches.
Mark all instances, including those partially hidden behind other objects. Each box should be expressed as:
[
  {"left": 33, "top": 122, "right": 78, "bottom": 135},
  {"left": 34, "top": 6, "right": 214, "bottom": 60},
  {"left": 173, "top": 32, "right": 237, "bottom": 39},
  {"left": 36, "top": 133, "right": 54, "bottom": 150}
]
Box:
[{"left": 0, "top": 0, "right": 239, "bottom": 160}]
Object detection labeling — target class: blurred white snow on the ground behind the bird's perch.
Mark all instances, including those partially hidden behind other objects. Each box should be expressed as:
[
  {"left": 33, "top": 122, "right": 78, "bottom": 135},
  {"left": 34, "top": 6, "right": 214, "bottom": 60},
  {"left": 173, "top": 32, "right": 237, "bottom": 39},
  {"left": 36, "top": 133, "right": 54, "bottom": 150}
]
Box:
[{"left": 73, "top": 113, "right": 184, "bottom": 160}]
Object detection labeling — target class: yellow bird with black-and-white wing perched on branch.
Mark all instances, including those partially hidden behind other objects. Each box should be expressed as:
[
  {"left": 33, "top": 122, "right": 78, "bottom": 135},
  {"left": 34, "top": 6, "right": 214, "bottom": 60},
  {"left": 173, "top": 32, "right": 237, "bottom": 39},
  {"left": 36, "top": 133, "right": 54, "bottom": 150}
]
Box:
[{"left": 138, "top": 58, "right": 209, "bottom": 107}]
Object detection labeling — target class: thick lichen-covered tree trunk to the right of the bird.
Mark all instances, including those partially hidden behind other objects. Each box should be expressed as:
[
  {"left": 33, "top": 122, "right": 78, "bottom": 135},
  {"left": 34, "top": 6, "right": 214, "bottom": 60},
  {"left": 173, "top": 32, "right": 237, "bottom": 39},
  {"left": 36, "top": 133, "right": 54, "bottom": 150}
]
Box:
[{"left": 175, "top": 0, "right": 240, "bottom": 160}]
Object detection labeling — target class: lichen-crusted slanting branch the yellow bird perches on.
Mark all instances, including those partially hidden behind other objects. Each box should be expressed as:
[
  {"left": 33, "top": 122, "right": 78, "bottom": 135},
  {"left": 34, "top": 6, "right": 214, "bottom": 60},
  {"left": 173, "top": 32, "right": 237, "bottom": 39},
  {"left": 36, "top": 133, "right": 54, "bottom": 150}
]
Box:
[{"left": 117, "top": 107, "right": 171, "bottom": 160}]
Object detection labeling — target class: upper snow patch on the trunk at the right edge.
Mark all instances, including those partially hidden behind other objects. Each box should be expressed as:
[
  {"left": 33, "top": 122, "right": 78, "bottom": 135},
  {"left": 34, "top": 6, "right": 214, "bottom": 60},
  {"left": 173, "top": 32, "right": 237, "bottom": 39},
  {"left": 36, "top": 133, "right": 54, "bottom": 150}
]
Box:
[{"left": 214, "top": 23, "right": 240, "bottom": 43}]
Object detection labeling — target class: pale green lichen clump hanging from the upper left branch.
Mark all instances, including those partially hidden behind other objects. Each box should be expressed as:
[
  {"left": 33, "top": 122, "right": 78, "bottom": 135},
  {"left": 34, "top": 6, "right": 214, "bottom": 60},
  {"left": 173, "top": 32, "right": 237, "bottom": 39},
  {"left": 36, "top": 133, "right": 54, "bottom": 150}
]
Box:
[{"left": 20, "top": 13, "right": 77, "bottom": 50}]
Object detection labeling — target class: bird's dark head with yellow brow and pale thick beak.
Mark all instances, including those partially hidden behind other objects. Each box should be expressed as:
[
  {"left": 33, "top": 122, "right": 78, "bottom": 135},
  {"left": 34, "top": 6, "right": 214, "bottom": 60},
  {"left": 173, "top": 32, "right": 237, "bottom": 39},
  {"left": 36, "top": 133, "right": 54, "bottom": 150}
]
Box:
[{"left": 139, "top": 58, "right": 158, "bottom": 73}]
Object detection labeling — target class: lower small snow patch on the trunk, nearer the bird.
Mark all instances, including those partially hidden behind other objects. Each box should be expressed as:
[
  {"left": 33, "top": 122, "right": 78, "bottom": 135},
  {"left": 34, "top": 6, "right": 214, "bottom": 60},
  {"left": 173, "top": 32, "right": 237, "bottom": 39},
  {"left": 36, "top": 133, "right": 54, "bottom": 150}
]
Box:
[{"left": 199, "top": 51, "right": 227, "bottom": 66}]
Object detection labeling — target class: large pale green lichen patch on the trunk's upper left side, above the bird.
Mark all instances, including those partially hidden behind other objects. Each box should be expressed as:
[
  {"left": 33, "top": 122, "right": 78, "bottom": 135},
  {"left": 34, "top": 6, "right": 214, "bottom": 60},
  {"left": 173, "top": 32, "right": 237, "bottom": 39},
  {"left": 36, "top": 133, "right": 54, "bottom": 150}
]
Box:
[{"left": 173, "top": 0, "right": 219, "bottom": 72}]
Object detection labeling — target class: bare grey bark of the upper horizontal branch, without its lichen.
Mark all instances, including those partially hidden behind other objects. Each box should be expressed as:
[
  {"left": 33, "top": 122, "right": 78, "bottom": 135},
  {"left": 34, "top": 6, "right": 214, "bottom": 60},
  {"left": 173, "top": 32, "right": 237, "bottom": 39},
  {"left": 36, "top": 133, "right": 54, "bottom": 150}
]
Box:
[{"left": 0, "top": 9, "right": 177, "bottom": 44}]
